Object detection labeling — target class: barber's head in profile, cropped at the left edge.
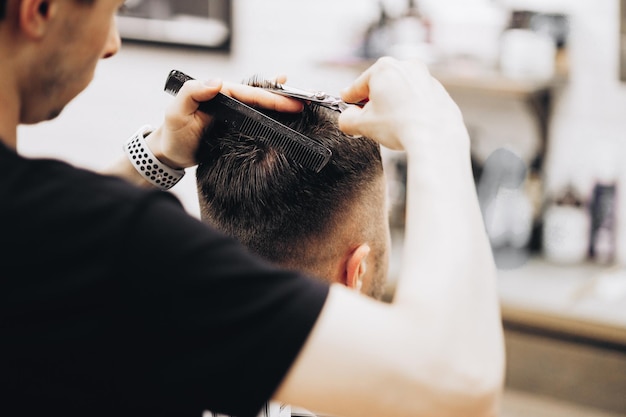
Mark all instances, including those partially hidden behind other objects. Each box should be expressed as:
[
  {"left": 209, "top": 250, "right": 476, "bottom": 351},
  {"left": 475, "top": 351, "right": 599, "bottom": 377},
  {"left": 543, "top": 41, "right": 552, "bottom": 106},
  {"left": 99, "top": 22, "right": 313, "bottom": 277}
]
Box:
[{"left": 0, "top": 0, "right": 119, "bottom": 127}]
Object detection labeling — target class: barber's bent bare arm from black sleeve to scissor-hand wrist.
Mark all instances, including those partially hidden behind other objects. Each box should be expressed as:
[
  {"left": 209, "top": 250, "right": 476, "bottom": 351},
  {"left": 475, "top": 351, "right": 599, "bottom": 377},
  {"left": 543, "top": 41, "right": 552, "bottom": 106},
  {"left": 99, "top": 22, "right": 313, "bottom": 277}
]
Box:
[{"left": 277, "top": 126, "right": 504, "bottom": 417}]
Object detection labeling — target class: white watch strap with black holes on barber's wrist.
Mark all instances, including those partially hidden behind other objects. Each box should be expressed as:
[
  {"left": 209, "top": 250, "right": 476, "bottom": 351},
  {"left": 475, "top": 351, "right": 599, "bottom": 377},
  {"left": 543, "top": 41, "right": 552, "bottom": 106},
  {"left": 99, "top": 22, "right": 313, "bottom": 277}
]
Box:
[{"left": 124, "top": 125, "right": 185, "bottom": 190}]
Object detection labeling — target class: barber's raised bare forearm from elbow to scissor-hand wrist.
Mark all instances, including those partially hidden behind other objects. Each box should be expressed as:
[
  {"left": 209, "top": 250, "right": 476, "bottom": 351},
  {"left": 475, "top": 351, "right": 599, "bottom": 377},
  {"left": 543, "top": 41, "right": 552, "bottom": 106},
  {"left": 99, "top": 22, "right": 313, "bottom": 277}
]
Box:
[{"left": 394, "top": 123, "right": 504, "bottom": 415}]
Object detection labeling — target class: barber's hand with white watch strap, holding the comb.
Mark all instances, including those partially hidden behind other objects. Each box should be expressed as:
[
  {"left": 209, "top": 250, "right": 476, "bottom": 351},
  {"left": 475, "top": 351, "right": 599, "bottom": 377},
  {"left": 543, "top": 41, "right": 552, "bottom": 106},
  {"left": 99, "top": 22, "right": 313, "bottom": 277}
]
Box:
[{"left": 147, "top": 77, "right": 302, "bottom": 168}]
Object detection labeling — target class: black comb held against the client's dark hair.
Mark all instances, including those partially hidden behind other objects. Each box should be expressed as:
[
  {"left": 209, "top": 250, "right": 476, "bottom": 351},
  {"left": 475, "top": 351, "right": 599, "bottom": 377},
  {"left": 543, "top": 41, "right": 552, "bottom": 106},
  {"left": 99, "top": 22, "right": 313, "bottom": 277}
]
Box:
[{"left": 165, "top": 70, "right": 332, "bottom": 172}]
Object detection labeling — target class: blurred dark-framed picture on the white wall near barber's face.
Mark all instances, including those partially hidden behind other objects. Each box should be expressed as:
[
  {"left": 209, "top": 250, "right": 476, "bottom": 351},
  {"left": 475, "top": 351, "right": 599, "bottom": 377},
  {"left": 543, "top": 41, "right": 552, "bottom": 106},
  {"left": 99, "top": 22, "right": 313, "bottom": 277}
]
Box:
[{"left": 118, "top": 0, "right": 232, "bottom": 50}]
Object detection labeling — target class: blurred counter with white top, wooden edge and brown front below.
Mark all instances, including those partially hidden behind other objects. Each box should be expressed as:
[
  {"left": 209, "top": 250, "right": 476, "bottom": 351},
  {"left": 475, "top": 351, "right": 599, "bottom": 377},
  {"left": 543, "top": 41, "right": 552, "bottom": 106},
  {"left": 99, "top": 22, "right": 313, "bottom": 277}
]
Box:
[{"left": 498, "top": 258, "right": 626, "bottom": 415}]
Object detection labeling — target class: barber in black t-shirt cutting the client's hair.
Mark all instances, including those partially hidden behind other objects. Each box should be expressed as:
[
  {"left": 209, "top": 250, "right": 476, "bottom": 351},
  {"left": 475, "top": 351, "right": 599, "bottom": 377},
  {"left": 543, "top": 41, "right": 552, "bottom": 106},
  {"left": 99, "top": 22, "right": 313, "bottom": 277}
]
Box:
[{"left": 0, "top": 0, "right": 504, "bottom": 417}]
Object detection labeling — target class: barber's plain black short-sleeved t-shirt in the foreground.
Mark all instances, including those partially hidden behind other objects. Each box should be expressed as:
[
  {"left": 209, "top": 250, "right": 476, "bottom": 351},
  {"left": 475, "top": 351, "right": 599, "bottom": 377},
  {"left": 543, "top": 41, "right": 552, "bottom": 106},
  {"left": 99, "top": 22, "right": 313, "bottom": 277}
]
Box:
[{"left": 0, "top": 143, "right": 328, "bottom": 417}]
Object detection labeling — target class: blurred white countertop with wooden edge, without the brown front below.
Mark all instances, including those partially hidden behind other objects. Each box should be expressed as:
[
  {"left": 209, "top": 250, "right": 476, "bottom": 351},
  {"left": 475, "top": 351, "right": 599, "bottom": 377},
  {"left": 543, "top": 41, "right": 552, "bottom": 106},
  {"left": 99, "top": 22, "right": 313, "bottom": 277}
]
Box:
[{"left": 498, "top": 258, "right": 626, "bottom": 350}]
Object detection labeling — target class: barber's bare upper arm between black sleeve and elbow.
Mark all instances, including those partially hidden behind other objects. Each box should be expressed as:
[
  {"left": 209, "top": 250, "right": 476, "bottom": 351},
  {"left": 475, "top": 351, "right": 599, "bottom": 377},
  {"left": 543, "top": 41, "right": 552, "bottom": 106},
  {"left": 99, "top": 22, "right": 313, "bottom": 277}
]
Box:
[{"left": 274, "top": 284, "right": 502, "bottom": 417}]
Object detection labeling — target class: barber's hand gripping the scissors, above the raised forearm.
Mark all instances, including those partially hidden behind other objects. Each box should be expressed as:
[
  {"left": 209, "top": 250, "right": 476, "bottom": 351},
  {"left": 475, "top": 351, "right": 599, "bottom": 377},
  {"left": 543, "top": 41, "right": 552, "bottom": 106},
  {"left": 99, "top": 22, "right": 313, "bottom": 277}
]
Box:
[{"left": 339, "top": 57, "right": 469, "bottom": 152}]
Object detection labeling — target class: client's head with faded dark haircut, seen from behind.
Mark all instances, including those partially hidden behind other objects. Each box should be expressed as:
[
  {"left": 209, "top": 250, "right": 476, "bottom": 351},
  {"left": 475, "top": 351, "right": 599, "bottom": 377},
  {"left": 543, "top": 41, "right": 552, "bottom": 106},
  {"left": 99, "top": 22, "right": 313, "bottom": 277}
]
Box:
[{"left": 196, "top": 91, "right": 389, "bottom": 298}]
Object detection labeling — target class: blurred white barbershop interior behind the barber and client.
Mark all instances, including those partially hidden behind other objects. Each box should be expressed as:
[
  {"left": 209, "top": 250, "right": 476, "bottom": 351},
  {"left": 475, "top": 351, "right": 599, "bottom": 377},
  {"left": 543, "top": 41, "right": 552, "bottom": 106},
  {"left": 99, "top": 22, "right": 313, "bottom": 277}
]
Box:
[{"left": 19, "top": 0, "right": 626, "bottom": 417}]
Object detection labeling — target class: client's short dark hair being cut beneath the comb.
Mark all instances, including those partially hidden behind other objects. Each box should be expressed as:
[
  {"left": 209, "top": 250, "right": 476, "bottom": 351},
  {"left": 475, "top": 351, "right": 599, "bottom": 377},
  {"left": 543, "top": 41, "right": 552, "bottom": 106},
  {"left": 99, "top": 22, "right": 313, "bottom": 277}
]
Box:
[{"left": 196, "top": 105, "right": 382, "bottom": 262}]
